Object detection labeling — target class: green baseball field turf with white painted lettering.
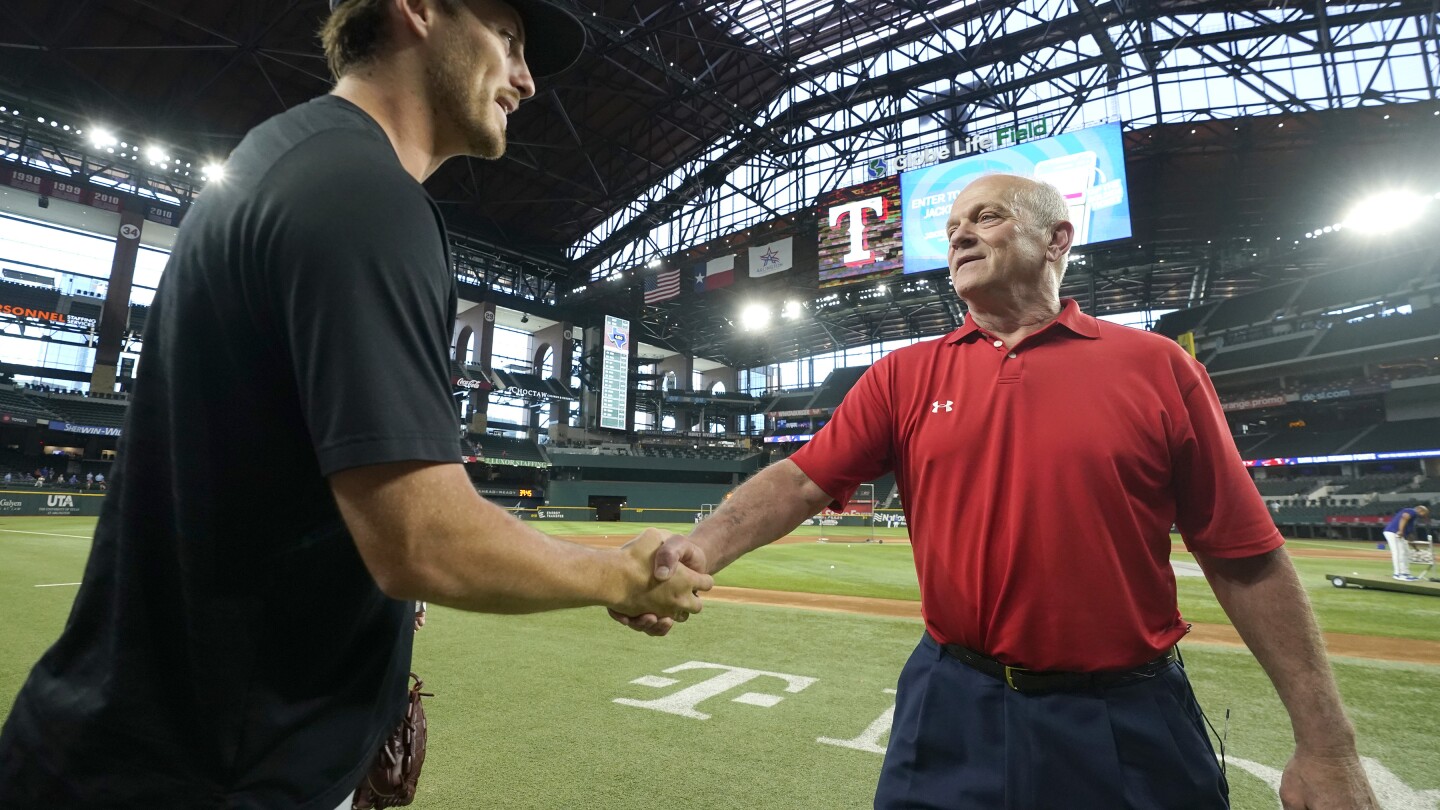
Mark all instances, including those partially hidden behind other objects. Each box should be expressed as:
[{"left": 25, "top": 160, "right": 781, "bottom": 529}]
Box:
[{"left": 0, "top": 517, "right": 1440, "bottom": 810}]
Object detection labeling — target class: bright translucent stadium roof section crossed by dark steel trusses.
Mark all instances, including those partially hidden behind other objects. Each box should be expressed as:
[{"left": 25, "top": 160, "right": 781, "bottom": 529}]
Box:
[{"left": 570, "top": 0, "right": 1440, "bottom": 276}]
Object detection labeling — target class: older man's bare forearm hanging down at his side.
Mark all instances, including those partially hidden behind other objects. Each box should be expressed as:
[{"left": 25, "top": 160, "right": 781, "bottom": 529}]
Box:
[{"left": 1195, "top": 549, "right": 1355, "bottom": 752}]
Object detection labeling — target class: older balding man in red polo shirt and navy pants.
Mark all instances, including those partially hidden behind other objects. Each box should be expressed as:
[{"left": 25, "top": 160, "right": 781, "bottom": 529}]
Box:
[{"left": 622, "top": 174, "right": 1375, "bottom": 810}]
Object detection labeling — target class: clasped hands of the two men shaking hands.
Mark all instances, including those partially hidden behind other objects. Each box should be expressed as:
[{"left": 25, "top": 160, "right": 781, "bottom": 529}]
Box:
[{"left": 609, "top": 529, "right": 714, "bottom": 636}]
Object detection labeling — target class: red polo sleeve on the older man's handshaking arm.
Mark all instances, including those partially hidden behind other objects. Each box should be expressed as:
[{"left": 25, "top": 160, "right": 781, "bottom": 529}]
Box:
[{"left": 791, "top": 360, "right": 894, "bottom": 512}]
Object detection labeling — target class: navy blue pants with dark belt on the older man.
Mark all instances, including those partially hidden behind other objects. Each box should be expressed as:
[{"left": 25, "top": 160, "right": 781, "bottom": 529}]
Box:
[{"left": 876, "top": 634, "right": 1230, "bottom": 810}]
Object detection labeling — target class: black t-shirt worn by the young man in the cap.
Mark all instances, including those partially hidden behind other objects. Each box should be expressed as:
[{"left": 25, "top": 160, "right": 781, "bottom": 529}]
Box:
[{"left": 0, "top": 97, "right": 459, "bottom": 810}]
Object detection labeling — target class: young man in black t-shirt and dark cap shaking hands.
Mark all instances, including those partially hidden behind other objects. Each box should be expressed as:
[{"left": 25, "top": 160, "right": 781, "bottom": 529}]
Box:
[{"left": 0, "top": 0, "right": 711, "bottom": 810}]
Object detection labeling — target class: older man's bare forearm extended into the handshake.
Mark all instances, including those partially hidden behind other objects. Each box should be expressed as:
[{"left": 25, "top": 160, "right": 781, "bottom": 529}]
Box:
[{"left": 690, "top": 460, "right": 831, "bottom": 574}]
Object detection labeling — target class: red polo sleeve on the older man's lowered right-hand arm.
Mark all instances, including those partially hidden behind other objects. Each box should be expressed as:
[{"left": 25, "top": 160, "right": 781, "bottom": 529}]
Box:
[{"left": 1172, "top": 357, "right": 1284, "bottom": 558}]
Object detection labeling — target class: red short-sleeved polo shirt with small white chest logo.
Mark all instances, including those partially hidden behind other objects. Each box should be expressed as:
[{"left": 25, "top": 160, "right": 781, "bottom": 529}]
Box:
[{"left": 791, "top": 298, "right": 1283, "bottom": 672}]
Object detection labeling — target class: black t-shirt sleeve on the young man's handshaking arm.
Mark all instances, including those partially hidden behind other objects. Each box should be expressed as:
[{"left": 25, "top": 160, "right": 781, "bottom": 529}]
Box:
[{"left": 268, "top": 138, "right": 461, "bottom": 476}]
